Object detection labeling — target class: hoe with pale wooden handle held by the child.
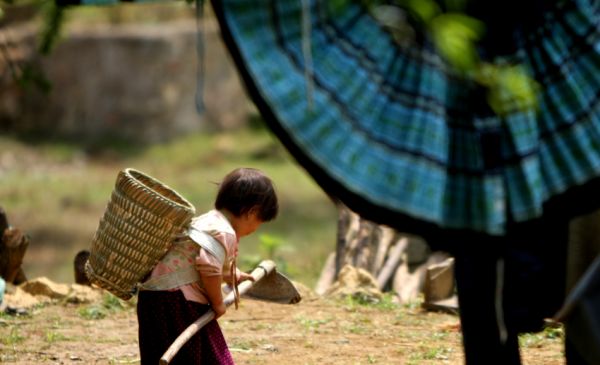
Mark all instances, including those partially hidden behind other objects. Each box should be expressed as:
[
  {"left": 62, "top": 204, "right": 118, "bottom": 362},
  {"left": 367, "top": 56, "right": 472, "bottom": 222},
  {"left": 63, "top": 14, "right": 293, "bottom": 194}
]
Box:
[{"left": 160, "top": 260, "right": 302, "bottom": 365}]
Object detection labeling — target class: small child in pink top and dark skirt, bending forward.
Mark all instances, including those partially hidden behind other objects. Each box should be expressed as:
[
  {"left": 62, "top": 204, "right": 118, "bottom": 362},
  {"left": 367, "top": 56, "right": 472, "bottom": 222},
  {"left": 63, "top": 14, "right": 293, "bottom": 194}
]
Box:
[{"left": 137, "top": 168, "right": 278, "bottom": 365}]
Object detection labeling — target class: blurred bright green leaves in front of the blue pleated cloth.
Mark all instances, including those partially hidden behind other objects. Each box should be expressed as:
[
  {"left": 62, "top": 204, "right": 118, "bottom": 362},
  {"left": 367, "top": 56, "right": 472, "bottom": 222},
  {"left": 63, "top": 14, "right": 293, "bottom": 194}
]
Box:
[{"left": 363, "top": 0, "right": 538, "bottom": 115}]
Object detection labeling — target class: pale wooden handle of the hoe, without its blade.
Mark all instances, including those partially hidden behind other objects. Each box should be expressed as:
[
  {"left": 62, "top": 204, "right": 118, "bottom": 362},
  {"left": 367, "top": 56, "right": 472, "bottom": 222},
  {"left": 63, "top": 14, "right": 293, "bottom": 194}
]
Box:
[{"left": 159, "top": 260, "right": 275, "bottom": 365}]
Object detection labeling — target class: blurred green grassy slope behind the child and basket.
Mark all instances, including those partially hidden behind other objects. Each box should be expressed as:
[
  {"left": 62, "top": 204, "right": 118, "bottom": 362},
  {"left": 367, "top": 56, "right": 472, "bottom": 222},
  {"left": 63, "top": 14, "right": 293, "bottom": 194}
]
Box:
[{"left": 0, "top": 128, "right": 337, "bottom": 286}]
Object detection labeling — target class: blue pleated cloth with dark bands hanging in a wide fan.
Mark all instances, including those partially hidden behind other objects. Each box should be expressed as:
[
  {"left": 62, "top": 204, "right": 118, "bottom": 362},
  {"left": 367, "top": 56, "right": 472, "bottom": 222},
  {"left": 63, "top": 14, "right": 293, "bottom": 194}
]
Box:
[{"left": 212, "top": 0, "right": 600, "bottom": 236}]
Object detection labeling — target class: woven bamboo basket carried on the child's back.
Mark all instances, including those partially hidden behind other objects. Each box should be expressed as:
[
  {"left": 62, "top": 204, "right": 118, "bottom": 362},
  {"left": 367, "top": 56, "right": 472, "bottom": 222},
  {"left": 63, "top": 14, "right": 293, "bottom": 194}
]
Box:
[{"left": 85, "top": 168, "right": 195, "bottom": 300}]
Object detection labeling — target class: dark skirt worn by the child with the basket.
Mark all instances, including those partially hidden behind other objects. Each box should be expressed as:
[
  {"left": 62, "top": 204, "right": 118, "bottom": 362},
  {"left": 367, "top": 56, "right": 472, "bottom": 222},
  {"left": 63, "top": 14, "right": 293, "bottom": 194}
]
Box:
[{"left": 137, "top": 290, "right": 234, "bottom": 365}]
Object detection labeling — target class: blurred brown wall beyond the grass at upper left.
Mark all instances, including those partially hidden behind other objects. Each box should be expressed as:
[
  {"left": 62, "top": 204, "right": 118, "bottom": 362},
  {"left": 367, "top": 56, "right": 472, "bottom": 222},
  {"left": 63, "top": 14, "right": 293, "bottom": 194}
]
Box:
[{"left": 0, "top": 11, "right": 251, "bottom": 143}]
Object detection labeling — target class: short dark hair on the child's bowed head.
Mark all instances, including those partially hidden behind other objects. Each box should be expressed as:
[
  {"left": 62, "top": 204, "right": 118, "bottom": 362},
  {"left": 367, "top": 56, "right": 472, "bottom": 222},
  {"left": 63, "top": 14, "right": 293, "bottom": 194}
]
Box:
[{"left": 215, "top": 168, "right": 279, "bottom": 222}]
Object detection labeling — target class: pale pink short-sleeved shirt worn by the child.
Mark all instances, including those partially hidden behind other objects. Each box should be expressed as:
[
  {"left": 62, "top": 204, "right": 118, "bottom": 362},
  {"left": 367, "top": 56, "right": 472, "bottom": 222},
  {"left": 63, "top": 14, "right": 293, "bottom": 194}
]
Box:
[{"left": 150, "top": 209, "right": 239, "bottom": 304}]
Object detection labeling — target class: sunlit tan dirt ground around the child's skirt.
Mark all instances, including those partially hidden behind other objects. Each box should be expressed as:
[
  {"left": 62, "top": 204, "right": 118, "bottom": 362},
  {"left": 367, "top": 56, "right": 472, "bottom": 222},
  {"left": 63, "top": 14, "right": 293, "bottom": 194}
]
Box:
[{"left": 0, "top": 288, "right": 564, "bottom": 365}]
